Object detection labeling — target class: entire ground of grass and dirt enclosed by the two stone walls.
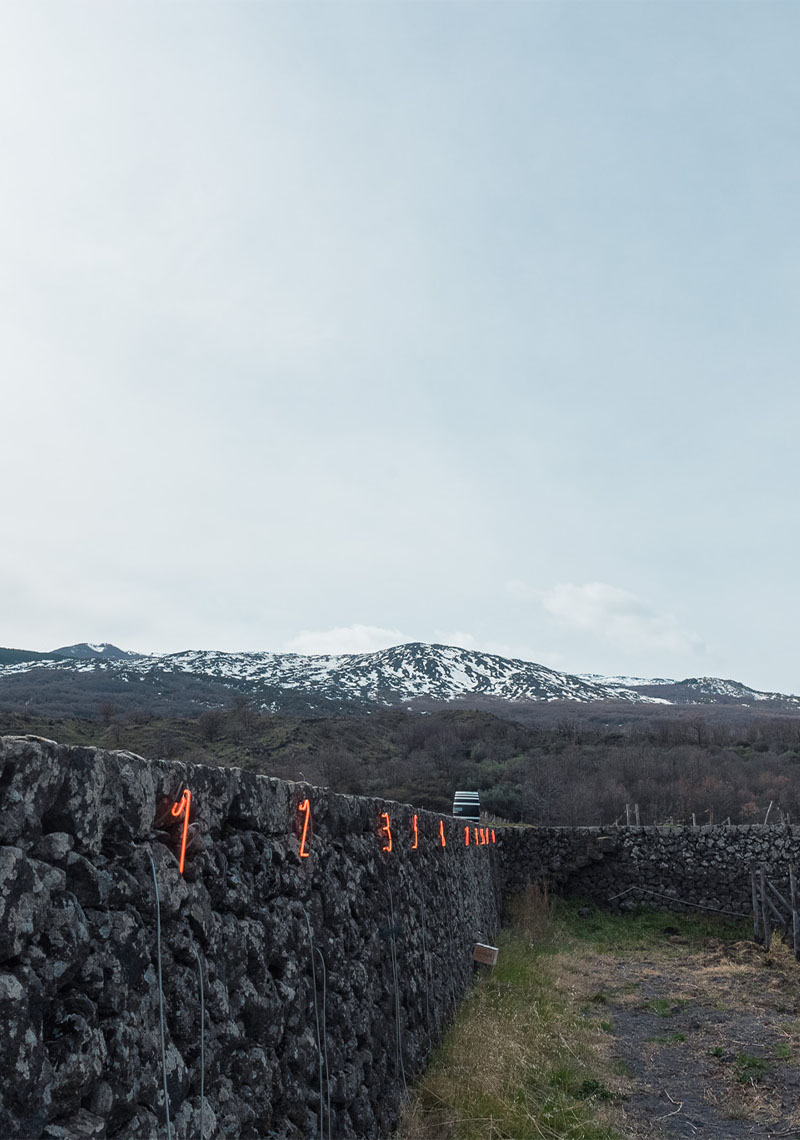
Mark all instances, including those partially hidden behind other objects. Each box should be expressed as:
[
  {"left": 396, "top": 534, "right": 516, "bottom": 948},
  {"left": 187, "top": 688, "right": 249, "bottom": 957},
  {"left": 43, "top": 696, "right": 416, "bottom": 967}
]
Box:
[{"left": 398, "top": 891, "right": 800, "bottom": 1140}]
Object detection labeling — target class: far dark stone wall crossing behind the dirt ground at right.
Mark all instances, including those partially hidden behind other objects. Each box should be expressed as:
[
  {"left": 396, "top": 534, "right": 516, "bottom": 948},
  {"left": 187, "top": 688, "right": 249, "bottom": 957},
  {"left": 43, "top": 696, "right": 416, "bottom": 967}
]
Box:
[{"left": 498, "top": 824, "right": 800, "bottom": 914}]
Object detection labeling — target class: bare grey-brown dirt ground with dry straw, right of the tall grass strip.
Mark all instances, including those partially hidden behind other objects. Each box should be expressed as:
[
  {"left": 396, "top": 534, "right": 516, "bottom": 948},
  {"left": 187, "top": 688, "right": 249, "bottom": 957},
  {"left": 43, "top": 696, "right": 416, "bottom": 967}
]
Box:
[{"left": 562, "top": 926, "right": 800, "bottom": 1140}]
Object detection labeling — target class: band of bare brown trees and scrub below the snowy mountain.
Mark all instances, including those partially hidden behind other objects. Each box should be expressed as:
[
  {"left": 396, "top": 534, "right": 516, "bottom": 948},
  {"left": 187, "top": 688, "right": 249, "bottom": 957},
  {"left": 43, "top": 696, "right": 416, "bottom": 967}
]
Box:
[{"left": 0, "top": 698, "right": 800, "bottom": 825}]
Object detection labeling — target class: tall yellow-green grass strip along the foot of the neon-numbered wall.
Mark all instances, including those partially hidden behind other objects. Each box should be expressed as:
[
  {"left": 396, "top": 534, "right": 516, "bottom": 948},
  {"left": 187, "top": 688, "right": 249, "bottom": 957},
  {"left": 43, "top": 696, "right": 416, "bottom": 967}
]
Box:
[{"left": 397, "top": 931, "right": 619, "bottom": 1140}]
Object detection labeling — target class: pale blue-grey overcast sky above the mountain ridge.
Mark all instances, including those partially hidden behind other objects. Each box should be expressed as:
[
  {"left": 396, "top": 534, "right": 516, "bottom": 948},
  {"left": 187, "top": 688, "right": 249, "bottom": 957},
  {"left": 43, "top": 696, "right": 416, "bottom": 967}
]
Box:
[{"left": 0, "top": 0, "right": 800, "bottom": 692}]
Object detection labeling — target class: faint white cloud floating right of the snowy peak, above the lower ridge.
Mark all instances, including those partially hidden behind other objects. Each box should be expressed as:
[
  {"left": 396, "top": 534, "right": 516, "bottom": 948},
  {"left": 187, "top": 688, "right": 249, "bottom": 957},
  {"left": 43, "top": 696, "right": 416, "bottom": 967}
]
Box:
[{"left": 539, "top": 581, "right": 705, "bottom": 653}]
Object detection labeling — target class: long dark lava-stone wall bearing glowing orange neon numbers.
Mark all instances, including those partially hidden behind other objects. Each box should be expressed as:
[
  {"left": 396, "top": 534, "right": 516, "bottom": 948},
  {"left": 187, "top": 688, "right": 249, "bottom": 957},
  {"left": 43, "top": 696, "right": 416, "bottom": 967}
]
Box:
[{"left": 0, "top": 738, "right": 501, "bottom": 1140}]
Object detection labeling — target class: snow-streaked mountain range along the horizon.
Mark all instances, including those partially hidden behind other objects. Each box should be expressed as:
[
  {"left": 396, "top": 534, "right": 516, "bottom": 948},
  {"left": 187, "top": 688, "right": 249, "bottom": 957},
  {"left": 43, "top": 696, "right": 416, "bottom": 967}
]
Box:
[{"left": 0, "top": 642, "right": 800, "bottom": 710}]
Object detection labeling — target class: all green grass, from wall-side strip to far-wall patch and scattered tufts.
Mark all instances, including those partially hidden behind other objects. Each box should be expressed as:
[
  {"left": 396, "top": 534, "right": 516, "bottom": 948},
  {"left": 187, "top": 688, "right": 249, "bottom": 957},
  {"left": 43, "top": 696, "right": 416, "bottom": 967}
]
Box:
[{"left": 395, "top": 888, "right": 760, "bottom": 1140}]
